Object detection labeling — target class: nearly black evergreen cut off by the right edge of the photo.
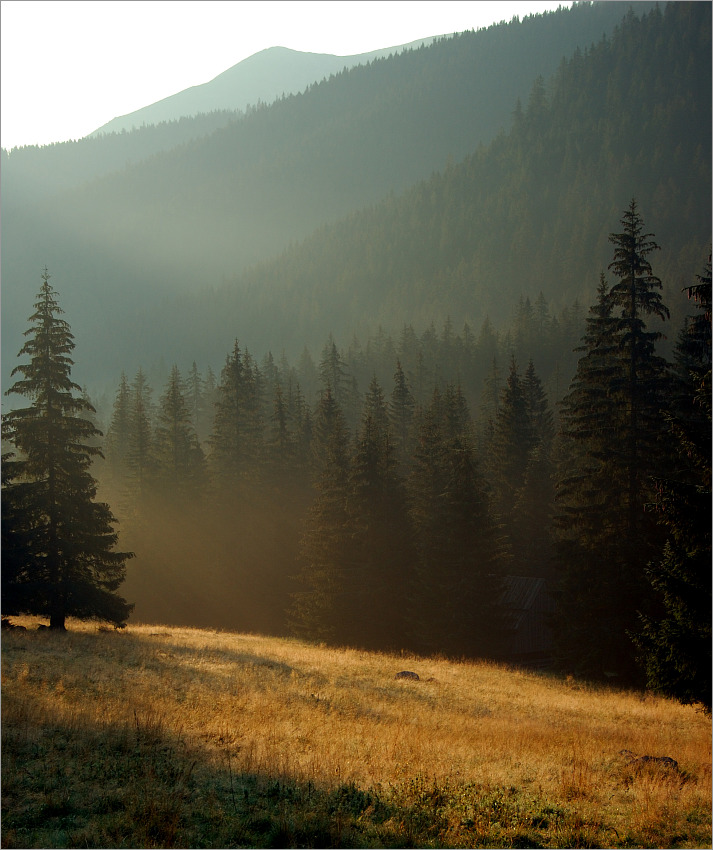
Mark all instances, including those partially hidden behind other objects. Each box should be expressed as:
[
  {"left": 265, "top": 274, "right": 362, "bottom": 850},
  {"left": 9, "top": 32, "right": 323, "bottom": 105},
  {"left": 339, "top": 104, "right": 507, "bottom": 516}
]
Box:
[{"left": 636, "top": 253, "right": 712, "bottom": 713}]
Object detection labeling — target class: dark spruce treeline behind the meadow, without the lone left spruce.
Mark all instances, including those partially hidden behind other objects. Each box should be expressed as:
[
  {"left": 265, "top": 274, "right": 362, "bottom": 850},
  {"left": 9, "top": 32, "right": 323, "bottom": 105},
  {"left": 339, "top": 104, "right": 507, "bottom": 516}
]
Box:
[{"left": 97, "top": 202, "right": 711, "bottom": 698}]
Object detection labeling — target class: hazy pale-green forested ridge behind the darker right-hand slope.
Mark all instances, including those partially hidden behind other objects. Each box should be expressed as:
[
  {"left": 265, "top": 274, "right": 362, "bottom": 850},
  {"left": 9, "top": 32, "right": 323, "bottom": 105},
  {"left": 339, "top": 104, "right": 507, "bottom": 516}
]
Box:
[{"left": 2, "top": 3, "right": 649, "bottom": 388}]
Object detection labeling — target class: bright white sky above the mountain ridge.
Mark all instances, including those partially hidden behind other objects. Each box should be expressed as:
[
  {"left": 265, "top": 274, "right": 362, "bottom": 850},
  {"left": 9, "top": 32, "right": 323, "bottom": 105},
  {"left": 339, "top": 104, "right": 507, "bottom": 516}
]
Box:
[{"left": 0, "top": 0, "right": 570, "bottom": 149}]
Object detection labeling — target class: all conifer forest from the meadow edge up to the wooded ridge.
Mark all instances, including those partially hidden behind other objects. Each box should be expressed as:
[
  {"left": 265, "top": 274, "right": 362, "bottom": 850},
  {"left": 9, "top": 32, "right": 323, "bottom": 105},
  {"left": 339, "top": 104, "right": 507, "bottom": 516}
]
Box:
[{"left": 2, "top": 2, "right": 712, "bottom": 712}]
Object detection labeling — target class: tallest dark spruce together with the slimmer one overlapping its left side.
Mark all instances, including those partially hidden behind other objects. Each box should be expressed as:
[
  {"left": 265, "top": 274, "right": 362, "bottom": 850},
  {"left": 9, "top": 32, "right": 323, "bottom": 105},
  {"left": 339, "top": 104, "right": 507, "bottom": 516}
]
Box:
[{"left": 558, "top": 201, "right": 668, "bottom": 681}]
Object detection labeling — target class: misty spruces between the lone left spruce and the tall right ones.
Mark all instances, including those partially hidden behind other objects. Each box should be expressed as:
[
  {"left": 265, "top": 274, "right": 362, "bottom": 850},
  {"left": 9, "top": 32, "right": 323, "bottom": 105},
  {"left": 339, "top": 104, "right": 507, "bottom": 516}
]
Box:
[{"left": 100, "top": 295, "right": 584, "bottom": 653}]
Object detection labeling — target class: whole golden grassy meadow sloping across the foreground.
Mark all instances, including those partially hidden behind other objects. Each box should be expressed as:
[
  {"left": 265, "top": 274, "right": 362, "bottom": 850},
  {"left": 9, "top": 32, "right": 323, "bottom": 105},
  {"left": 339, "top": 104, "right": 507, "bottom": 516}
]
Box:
[{"left": 2, "top": 618, "right": 711, "bottom": 848}]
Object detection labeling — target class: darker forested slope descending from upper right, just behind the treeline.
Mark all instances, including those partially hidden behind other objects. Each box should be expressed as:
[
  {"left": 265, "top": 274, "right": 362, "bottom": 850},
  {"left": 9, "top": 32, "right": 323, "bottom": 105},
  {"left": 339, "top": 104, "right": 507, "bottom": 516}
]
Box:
[{"left": 107, "top": 3, "right": 711, "bottom": 374}]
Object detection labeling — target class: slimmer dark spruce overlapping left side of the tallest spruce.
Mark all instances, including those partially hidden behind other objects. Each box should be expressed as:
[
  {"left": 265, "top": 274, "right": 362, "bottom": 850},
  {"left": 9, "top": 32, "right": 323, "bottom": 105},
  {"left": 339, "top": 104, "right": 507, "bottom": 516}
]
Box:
[{"left": 555, "top": 274, "right": 623, "bottom": 677}]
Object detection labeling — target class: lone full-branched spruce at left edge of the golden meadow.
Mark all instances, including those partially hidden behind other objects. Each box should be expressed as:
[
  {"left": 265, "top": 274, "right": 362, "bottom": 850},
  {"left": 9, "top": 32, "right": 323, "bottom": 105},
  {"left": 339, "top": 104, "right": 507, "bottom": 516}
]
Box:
[{"left": 3, "top": 269, "right": 133, "bottom": 630}]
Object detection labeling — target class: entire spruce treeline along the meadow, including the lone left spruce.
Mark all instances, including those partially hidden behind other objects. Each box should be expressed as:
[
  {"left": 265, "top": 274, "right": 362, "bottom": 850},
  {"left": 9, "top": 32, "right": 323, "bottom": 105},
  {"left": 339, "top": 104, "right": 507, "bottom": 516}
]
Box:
[{"left": 2, "top": 200, "right": 711, "bottom": 710}]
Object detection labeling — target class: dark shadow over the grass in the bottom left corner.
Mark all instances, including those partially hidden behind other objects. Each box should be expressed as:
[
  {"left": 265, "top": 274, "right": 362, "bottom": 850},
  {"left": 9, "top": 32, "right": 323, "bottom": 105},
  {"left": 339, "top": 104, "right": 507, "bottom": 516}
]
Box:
[{"left": 2, "top": 684, "right": 405, "bottom": 848}]
